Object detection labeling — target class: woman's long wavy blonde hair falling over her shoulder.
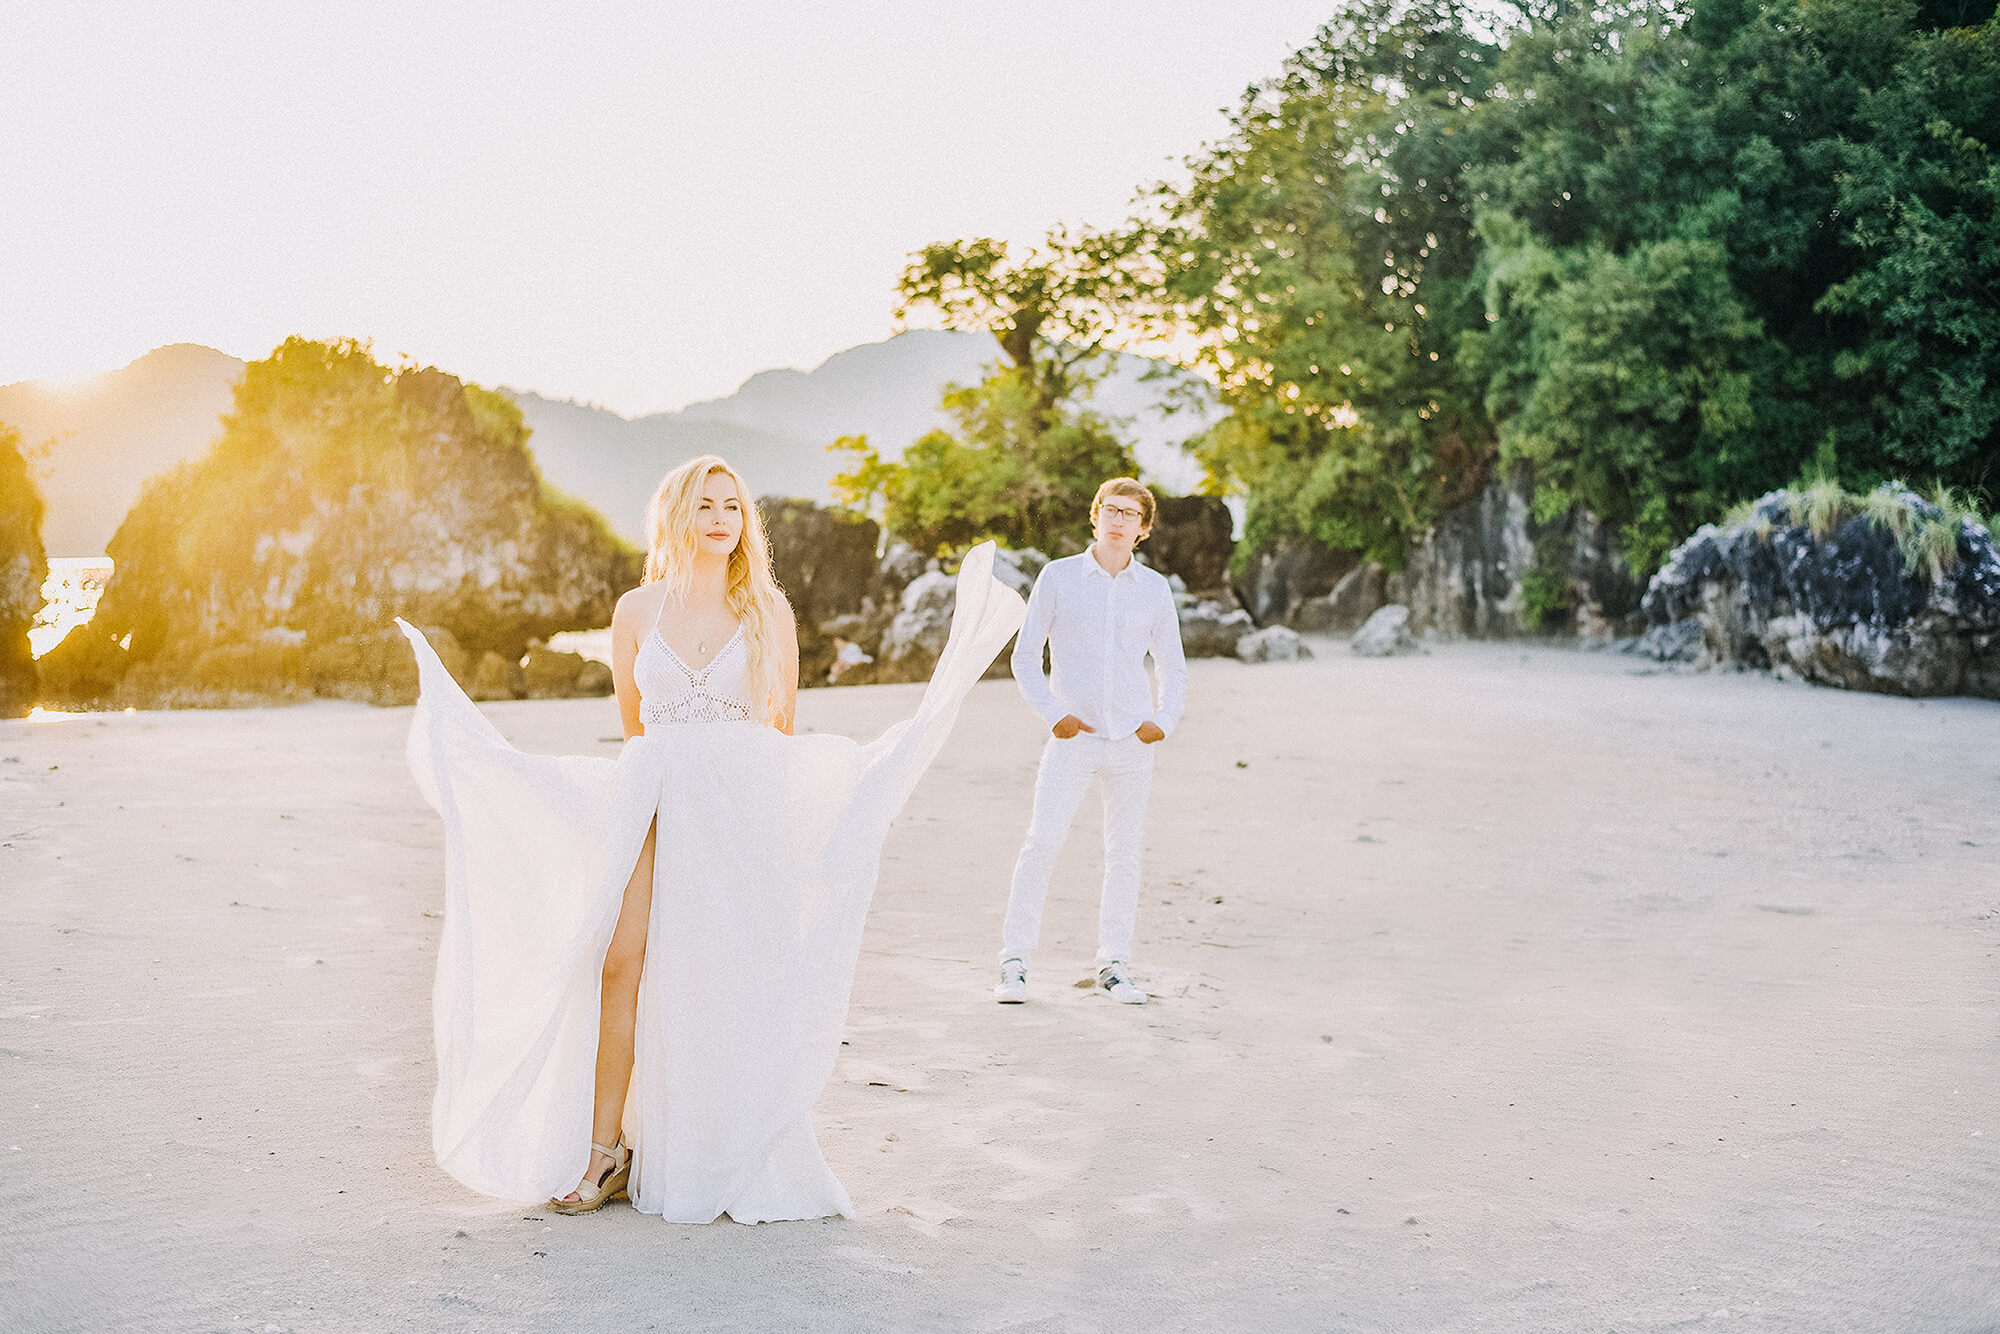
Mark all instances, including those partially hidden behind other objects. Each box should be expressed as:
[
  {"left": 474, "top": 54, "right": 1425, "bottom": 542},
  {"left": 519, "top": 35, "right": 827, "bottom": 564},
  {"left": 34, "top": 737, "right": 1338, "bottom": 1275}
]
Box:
[{"left": 646, "top": 454, "right": 792, "bottom": 722}]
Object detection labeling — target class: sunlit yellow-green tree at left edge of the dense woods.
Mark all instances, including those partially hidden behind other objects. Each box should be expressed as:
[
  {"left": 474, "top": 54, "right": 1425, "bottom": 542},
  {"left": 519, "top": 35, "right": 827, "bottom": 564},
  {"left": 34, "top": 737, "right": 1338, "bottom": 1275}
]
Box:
[{"left": 1126, "top": 0, "right": 1496, "bottom": 566}]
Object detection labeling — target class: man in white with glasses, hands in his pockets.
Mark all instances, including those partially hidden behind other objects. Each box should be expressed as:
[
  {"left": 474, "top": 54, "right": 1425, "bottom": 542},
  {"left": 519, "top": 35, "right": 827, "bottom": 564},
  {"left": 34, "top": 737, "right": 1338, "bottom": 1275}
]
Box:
[{"left": 994, "top": 478, "right": 1188, "bottom": 1004}]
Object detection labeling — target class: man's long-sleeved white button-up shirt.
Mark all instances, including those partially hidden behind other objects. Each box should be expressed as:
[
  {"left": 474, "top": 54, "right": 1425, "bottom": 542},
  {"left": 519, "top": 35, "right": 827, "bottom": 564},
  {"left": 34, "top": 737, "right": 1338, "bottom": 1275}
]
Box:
[{"left": 1014, "top": 550, "right": 1188, "bottom": 740}]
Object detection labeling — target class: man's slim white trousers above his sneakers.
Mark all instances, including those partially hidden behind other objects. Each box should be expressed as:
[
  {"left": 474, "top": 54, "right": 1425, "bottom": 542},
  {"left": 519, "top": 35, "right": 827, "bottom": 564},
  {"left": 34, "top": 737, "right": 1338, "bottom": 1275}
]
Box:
[{"left": 1000, "top": 732, "right": 1152, "bottom": 968}]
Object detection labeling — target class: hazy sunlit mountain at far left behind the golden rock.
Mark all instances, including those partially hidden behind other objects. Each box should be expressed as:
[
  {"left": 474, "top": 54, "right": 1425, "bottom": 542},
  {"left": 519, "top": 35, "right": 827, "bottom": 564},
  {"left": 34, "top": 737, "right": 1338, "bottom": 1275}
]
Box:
[{"left": 0, "top": 342, "right": 244, "bottom": 556}]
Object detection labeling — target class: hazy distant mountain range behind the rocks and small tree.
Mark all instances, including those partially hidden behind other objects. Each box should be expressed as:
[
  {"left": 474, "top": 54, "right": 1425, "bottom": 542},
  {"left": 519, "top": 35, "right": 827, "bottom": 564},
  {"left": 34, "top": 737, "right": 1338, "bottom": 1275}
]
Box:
[{"left": 0, "top": 330, "right": 1206, "bottom": 556}]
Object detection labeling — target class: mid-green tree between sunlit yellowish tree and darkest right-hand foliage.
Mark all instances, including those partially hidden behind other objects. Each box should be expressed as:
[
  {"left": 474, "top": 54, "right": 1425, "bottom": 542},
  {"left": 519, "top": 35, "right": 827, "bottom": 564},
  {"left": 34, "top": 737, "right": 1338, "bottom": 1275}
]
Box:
[{"left": 1456, "top": 1, "right": 1770, "bottom": 570}]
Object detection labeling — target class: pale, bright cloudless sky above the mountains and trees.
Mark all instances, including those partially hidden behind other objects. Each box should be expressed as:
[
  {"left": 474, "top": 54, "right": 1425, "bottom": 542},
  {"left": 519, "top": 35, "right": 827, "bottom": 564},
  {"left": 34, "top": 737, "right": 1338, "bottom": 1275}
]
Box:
[{"left": 0, "top": 0, "right": 1338, "bottom": 414}]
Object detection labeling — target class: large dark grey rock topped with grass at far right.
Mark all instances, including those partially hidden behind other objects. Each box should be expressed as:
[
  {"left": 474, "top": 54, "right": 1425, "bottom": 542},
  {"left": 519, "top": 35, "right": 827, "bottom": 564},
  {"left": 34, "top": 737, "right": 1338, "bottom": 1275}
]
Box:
[{"left": 1646, "top": 484, "right": 2000, "bottom": 700}]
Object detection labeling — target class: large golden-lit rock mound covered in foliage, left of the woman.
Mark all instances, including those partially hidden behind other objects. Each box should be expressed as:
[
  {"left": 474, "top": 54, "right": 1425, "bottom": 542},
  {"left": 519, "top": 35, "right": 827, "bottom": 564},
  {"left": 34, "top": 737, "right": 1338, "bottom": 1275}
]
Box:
[{"left": 50, "top": 338, "right": 640, "bottom": 708}]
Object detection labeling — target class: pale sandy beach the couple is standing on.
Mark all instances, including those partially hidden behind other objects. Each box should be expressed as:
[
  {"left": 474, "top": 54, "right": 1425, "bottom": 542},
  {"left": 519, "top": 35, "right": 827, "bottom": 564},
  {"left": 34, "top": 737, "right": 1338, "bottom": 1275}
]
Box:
[{"left": 0, "top": 640, "right": 2000, "bottom": 1334}]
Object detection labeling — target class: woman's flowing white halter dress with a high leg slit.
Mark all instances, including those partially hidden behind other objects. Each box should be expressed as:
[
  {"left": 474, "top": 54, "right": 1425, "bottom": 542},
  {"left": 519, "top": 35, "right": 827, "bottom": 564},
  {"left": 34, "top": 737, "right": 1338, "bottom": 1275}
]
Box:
[{"left": 404, "top": 544, "right": 1024, "bottom": 1222}]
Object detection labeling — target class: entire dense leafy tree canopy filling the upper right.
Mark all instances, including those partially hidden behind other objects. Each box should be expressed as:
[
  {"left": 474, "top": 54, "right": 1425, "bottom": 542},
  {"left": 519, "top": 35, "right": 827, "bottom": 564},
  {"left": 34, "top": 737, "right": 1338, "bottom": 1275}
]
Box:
[{"left": 1094, "top": 0, "right": 2000, "bottom": 570}]
